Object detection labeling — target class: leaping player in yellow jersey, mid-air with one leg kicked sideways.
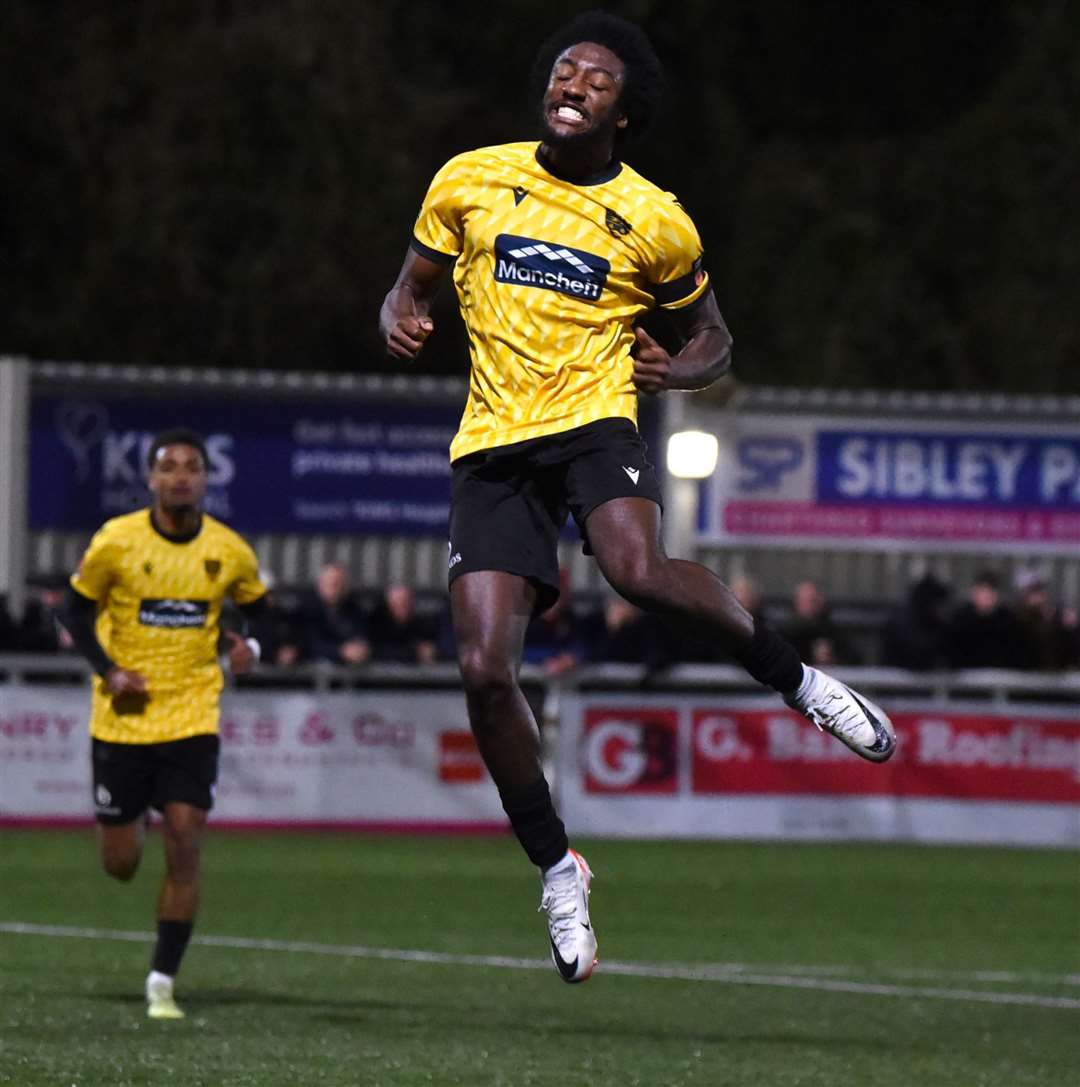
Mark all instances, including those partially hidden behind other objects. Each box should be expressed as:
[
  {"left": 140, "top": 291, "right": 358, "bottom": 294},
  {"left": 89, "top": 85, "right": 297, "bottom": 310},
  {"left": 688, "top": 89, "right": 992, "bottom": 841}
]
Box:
[{"left": 379, "top": 12, "right": 895, "bottom": 982}]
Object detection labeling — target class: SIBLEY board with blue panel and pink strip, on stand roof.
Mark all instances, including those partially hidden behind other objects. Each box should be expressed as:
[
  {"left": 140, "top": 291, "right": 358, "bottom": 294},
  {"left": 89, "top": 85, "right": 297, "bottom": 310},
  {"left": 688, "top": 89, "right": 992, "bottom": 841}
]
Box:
[{"left": 699, "top": 413, "right": 1080, "bottom": 553}]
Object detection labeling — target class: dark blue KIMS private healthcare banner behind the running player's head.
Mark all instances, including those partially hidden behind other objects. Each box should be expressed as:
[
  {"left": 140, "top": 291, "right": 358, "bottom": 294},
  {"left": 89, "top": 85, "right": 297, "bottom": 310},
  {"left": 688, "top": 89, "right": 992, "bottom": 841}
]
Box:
[{"left": 29, "top": 396, "right": 461, "bottom": 536}]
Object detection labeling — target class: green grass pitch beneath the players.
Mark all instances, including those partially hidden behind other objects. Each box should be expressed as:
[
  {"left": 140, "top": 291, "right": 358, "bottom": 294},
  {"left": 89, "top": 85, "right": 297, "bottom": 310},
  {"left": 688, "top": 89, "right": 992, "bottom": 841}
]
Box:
[{"left": 0, "top": 829, "right": 1080, "bottom": 1087}]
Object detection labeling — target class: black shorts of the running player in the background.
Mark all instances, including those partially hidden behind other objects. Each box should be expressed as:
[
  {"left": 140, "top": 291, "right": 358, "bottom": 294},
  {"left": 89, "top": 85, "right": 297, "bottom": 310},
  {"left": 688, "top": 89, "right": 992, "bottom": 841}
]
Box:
[{"left": 91, "top": 734, "right": 221, "bottom": 826}]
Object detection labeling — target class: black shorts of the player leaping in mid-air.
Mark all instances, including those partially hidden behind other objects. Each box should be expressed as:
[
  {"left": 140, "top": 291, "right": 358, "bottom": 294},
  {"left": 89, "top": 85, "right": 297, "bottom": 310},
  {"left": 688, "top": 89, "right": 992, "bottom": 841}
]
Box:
[{"left": 449, "top": 418, "right": 663, "bottom": 611}]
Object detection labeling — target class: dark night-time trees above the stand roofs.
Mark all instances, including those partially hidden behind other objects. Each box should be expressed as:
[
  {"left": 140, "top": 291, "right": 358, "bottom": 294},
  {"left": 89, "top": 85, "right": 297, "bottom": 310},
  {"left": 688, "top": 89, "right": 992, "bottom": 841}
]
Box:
[{"left": 0, "top": 0, "right": 1080, "bottom": 392}]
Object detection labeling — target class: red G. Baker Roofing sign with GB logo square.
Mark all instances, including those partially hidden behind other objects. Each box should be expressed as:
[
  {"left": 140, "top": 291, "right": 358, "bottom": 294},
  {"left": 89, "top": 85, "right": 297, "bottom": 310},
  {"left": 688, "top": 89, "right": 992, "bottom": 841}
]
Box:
[{"left": 581, "top": 701, "right": 1080, "bottom": 804}]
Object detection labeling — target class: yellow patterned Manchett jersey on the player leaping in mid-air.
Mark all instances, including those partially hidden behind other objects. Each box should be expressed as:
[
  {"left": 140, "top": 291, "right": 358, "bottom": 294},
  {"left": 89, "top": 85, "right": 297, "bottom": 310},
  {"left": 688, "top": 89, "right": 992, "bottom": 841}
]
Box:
[{"left": 413, "top": 142, "right": 708, "bottom": 460}]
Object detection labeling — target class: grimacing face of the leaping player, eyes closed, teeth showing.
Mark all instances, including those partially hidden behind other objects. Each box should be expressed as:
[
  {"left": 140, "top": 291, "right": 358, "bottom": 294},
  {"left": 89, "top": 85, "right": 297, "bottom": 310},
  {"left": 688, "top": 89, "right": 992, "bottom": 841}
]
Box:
[{"left": 541, "top": 41, "right": 627, "bottom": 145}]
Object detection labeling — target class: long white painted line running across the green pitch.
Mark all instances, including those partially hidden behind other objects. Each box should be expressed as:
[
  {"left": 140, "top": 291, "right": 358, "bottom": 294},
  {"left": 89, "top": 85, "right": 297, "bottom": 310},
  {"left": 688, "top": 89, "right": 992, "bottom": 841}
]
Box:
[{"left": 0, "top": 921, "right": 1080, "bottom": 1011}]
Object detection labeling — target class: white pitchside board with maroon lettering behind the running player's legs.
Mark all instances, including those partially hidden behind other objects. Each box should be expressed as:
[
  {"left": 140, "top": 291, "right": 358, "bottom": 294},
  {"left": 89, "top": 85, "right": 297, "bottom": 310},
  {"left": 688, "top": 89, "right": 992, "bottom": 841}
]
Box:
[{"left": 0, "top": 686, "right": 505, "bottom": 829}]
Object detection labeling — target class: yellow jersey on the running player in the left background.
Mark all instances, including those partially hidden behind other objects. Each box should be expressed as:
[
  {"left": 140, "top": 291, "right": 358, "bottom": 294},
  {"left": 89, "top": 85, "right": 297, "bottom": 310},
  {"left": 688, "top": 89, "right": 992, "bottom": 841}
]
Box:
[{"left": 72, "top": 510, "right": 266, "bottom": 744}]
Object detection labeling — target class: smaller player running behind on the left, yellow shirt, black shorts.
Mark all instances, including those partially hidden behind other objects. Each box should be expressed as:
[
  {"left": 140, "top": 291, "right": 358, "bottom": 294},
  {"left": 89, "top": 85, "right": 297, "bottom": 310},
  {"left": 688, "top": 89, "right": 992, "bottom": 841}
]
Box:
[{"left": 64, "top": 429, "right": 266, "bottom": 1020}]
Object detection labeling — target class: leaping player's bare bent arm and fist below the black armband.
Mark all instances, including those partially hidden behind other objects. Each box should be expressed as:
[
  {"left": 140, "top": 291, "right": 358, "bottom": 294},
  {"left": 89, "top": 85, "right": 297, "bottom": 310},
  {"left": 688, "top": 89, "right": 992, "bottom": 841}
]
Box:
[{"left": 633, "top": 290, "right": 732, "bottom": 395}]
